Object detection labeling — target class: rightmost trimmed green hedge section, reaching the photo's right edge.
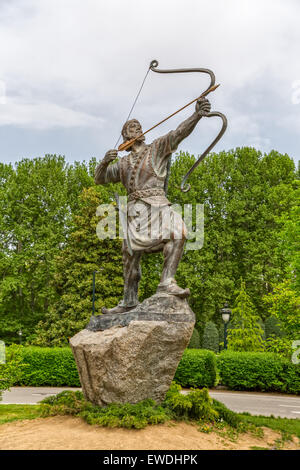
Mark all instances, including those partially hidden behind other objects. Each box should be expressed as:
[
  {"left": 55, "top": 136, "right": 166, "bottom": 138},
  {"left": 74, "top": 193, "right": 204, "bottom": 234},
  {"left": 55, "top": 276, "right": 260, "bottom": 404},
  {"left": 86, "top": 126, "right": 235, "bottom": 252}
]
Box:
[{"left": 217, "top": 351, "right": 300, "bottom": 394}]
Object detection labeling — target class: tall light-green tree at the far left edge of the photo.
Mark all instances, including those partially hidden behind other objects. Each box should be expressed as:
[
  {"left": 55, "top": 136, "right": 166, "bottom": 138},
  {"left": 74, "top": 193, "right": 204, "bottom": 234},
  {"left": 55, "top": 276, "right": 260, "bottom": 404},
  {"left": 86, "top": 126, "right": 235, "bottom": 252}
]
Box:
[{"left": 0, "top": 155, "right": 93, "bottom": 343}]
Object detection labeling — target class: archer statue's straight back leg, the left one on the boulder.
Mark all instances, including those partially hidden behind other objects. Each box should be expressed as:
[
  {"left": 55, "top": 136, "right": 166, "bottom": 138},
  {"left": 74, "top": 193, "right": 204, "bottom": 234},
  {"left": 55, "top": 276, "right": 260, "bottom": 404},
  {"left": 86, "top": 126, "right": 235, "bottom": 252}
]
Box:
[{"left": 102, "top": 243, "right": 142, "bottom": 314}]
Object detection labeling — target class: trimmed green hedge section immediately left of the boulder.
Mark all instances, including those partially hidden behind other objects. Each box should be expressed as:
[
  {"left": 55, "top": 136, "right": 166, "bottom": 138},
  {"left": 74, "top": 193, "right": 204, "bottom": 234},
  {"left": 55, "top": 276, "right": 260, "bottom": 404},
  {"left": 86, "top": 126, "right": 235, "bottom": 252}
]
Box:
[{"left": 14, "top": 346, "right": 80, "bottom": 387}]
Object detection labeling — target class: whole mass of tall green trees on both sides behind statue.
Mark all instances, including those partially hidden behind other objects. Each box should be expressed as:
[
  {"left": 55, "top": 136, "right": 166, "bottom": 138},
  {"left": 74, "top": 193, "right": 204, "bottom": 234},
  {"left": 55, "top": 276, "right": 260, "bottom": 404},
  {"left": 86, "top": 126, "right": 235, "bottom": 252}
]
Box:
[{"left": 0, "top": 148, "right": 299, "bottom": 345}]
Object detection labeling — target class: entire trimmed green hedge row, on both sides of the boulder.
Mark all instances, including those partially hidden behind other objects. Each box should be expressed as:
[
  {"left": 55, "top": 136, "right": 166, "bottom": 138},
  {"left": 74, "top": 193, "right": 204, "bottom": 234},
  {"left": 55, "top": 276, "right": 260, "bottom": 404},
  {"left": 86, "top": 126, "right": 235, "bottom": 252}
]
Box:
[{"left": 8, "top": 346, "right": 300, "bottom": 394}]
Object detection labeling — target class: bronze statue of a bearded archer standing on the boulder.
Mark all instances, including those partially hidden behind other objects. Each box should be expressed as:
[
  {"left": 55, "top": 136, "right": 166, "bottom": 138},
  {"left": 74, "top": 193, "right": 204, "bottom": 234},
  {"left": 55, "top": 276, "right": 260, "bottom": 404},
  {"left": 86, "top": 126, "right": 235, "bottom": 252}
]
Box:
[{"left": 95, "top": 98, "right": 211, "bottom": 313}]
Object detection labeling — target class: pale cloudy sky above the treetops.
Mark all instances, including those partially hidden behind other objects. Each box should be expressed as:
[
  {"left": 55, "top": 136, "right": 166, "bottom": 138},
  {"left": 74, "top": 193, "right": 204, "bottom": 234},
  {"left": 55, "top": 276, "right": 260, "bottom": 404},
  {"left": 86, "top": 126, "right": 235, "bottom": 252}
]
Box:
[{"left": 0, "top": 0, "right": 300, "bottom": 166}]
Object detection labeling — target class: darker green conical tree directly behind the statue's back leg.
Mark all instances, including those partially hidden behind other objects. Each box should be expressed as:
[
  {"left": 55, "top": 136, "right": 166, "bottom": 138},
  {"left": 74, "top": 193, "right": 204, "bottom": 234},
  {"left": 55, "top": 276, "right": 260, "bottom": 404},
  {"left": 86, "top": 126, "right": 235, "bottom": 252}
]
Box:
[{"left": 31, "top": 187, "right": 123, "bottom": 346}]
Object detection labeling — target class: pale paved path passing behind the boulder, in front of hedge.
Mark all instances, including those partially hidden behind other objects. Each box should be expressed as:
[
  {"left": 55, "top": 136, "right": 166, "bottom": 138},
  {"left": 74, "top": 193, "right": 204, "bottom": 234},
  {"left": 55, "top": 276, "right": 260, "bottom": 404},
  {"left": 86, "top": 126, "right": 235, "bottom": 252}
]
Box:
[{"left": 0, "top": 387, "right": 300, "bottom": 418}]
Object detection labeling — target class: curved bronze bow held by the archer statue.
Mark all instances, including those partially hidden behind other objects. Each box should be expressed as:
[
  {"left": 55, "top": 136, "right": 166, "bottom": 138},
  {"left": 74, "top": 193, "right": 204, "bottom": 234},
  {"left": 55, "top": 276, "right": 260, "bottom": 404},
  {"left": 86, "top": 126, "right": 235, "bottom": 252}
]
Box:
[{"left": 149, "top": 60, "right": 227, "bottom": 193}]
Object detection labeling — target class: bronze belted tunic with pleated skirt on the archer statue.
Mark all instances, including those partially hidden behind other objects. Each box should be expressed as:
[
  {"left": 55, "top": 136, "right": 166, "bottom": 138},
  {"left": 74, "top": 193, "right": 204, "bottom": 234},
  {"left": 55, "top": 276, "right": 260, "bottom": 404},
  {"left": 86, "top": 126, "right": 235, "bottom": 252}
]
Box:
[{"left": 95, "top": 131, "right": 187, "bottom": 251}]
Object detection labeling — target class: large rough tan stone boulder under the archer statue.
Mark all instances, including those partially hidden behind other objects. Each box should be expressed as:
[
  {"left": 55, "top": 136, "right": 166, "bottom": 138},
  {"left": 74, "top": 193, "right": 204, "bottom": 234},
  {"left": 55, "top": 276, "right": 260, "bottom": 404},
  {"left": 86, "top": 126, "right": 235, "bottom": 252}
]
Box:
[{"left": 70, "top": 294, "right": 195, "bottom": 406}]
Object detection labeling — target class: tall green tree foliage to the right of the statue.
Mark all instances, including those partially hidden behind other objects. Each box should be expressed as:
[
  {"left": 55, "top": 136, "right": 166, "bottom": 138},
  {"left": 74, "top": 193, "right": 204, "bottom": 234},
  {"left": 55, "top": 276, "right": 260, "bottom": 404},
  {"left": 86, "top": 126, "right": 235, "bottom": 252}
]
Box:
[{"left": 168, "top": 148, "right": 296, "bottom": 328}]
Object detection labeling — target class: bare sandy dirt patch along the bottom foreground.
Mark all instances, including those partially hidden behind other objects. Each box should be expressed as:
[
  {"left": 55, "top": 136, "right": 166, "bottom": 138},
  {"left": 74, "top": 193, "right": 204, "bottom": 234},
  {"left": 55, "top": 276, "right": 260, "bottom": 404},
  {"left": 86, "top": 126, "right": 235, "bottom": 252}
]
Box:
[{"left": 0, "top": 416, "right": 298, "bottom": 450}]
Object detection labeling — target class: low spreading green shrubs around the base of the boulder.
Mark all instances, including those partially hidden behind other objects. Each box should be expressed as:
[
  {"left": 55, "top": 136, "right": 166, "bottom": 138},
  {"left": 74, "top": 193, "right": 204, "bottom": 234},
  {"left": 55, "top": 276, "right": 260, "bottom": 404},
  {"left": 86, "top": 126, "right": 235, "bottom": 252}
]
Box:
[{"left": 41, "top": 383, "right": 241, "bottom": 429}]
